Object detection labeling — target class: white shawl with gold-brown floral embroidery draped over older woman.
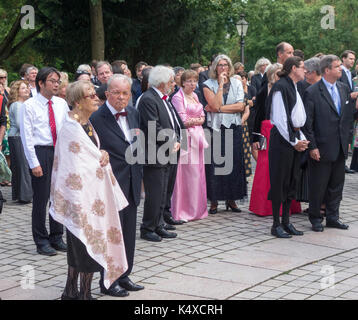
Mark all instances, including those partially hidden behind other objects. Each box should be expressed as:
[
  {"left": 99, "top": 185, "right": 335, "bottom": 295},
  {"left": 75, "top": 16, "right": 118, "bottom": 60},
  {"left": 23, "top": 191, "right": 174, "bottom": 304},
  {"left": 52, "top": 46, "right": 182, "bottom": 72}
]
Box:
[{"left": 50, "top": 116, "right": 128, "bottom": 288}]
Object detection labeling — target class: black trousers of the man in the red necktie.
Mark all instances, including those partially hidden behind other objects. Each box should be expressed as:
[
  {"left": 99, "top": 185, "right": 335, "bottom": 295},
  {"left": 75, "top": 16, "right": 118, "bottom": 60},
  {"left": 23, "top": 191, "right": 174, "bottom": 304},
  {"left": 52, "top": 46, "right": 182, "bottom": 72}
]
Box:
[{"left": 30, "top": 146, "right": 63, "bottom": 246}]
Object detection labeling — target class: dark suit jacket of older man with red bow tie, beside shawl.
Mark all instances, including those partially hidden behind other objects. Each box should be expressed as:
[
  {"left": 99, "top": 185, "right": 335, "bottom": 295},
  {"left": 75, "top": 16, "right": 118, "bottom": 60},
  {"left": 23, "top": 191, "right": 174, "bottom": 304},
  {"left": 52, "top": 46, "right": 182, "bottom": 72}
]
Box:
[{"left": 90, "top": 104, "right": 142, "bottom": 206}]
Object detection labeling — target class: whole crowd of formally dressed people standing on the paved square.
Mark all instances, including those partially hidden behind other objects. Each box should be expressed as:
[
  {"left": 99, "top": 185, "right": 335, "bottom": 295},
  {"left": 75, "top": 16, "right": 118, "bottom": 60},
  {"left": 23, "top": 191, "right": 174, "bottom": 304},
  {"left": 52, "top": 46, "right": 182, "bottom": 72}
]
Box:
[{"left": 0, "top": 42, "right": 358, "bottom": 300}]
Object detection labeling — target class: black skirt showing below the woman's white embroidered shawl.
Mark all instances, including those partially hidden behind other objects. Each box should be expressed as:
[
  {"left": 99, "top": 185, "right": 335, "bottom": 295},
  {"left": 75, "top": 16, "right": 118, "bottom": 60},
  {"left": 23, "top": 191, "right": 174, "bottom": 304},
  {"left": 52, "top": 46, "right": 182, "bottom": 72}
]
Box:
[{"left": 66, "top": 228, "right": 103, "bottom": 273}]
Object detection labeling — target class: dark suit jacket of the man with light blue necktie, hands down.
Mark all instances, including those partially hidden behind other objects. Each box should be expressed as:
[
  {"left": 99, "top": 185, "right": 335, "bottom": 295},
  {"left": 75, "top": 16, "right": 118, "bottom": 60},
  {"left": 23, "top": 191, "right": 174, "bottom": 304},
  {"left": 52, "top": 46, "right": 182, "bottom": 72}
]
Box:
[{"left": 303, "top": 80, "right": 353, "bottom": 162}]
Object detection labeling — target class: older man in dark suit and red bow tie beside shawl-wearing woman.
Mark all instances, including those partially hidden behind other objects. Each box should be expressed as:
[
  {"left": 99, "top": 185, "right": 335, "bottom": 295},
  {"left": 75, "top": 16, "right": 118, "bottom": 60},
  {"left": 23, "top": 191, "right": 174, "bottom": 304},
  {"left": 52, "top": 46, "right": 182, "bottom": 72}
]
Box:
[{"left": 90, "top": 74, "right": 144, "bottom": 297}]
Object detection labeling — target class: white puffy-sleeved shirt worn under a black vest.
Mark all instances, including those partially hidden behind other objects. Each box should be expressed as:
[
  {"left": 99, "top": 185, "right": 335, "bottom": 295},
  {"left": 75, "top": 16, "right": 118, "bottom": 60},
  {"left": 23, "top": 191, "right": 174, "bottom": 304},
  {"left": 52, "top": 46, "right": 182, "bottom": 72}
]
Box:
[{"left": 270, "top": 85, "right": 307, "bottom": 146}]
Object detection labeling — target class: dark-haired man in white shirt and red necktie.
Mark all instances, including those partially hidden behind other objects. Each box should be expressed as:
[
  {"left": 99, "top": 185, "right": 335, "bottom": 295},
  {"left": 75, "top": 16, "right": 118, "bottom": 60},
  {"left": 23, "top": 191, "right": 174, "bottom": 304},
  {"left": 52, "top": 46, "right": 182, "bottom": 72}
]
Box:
[{"left": 20, "top": 67, "right": 69, "bottom": 256}]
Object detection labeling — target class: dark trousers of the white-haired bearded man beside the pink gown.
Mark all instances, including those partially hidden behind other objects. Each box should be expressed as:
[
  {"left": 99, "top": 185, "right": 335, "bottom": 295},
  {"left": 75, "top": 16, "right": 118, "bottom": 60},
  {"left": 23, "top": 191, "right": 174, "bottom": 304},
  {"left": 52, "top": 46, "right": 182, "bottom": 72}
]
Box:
[{"left": 140, "top": 165, "right": 170, "bottom": 232}]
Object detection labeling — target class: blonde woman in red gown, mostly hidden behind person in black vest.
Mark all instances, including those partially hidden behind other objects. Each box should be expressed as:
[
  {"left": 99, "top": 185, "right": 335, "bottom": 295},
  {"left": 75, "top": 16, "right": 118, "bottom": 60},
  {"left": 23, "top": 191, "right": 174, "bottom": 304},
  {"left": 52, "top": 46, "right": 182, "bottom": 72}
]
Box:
[{"left": 249, "top": 63, "right": 301, "bottom": 216}]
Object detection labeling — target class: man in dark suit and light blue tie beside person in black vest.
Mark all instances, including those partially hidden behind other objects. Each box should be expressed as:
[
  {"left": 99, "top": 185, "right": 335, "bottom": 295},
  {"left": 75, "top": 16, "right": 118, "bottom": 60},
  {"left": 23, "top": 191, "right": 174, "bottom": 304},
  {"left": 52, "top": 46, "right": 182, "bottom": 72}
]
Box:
[{"left": 304, "top": 55, "right": 353, "bottom": 231}]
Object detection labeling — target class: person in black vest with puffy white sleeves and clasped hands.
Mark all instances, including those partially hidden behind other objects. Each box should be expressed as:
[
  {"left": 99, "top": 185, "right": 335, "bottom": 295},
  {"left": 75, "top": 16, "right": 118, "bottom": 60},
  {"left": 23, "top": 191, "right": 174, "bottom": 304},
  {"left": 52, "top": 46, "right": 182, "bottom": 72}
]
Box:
[{"left": 267, "top": 57, "right": 309, "bottom": 238}]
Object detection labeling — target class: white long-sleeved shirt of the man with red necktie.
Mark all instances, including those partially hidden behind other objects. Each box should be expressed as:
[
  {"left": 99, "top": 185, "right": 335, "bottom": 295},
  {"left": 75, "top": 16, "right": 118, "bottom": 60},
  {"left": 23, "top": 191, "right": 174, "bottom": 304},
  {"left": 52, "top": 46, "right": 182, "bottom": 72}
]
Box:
[{"left": 20, "top": 93, "right": 69, "bottom": 169}]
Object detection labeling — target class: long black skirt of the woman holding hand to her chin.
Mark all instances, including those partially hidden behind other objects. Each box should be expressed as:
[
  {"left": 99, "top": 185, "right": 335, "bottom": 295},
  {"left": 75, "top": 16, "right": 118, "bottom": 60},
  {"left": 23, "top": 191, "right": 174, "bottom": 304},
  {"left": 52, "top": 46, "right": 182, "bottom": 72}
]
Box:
[{"left": 205, "top": 125, "right": 247, "bottom": 201}]
